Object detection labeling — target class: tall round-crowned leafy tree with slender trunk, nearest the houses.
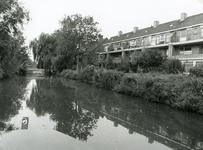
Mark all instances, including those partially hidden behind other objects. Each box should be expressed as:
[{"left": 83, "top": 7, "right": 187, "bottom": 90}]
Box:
[{"left": 60, "top": 14, "right": 99, "bottom": 71}]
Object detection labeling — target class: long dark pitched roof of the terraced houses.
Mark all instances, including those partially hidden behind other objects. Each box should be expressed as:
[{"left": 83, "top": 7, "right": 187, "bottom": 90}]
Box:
[{"left": 105, "top": 13, "right": 203, "bottom": 44}]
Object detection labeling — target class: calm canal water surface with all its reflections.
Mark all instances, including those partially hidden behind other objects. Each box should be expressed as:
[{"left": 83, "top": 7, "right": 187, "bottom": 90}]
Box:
[{"left": 0, "top": 77, "right": 203, "bottom": 150}]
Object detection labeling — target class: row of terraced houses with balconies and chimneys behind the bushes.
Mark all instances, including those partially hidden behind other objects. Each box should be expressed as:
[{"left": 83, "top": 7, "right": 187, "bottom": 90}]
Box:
[{"left": 97, "top": 13, "right": 203, "bottom": 71}]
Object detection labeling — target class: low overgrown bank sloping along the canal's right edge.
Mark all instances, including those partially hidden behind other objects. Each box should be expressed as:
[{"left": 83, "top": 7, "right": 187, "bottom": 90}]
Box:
[{"left": 60, "top": 66, "right": 203, "bottom": 114}]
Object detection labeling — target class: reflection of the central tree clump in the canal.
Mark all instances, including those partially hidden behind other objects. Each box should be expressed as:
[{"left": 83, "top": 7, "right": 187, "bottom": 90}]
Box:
[{"left": 26, "top": 79, "right": 97, "bottom": 141}]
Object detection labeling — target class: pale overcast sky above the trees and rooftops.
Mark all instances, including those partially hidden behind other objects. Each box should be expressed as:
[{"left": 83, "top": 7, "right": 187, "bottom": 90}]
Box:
[{"left": 19, "top": 0, "right": 203, "bottom": 44}]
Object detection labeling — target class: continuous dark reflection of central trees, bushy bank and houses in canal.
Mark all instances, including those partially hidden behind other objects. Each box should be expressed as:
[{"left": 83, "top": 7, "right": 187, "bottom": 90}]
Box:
[{"left": 27, "top": 78, "right": 203, "bottom": 149}]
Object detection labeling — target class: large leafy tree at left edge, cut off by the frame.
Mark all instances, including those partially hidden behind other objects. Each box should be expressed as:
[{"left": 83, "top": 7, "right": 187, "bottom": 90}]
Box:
[{"left": 0, "top": 0, "right": 29, "bottom": 76}]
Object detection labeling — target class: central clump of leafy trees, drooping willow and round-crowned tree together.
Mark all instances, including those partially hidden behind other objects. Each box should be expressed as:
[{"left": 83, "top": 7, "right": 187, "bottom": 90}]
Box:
[{"left": 29, "top": 14, "right": 99, "bottom": 72}]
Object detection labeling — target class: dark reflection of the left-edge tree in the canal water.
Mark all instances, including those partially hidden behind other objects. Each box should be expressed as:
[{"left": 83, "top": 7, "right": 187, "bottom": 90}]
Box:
[{"left": 0, "top": 78, "right": 27, "bottom": 131}]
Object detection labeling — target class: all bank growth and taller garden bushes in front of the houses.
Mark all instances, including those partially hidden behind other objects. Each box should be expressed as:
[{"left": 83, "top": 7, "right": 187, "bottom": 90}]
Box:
[{"left": 60, "top": 50, "right": 203, "bottom": 114}]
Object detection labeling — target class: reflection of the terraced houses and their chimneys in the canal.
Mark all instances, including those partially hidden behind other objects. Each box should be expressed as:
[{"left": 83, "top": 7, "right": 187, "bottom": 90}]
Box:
[{"left": 100, "top": 104, "right": 203, "bottom": 150}]
